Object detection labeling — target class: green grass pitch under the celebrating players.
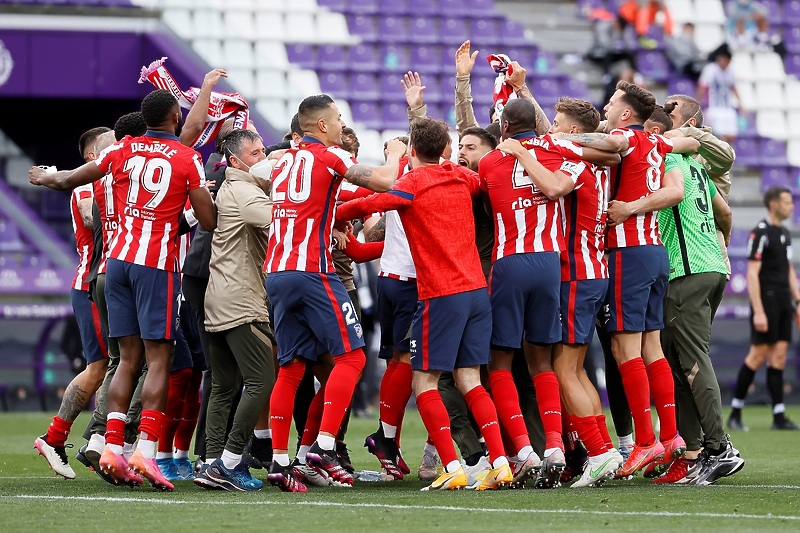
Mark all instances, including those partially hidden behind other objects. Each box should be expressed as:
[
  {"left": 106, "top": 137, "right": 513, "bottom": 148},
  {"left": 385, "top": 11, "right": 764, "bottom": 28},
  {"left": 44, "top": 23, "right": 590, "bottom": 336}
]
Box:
[{"left": 0, "top": 407, "right": 800, "bottom": 533}]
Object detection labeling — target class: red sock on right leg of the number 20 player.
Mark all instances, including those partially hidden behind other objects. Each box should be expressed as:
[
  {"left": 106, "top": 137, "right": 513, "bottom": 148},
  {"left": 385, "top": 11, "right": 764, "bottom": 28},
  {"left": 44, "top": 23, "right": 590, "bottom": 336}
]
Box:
[{"left": 319, "top": 348, "right": 367, "bottom": 435}]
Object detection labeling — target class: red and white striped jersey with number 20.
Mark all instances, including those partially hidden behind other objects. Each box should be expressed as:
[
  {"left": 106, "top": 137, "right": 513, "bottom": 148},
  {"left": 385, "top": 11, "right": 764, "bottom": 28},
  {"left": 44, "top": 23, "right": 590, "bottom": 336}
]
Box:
[{"left": 264, "top": 137, "right": 356, "bottom": 272}]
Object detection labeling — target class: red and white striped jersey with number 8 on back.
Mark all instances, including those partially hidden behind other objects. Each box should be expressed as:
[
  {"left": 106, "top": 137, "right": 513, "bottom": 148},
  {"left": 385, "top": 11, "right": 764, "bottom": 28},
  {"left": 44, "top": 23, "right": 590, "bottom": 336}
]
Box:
[{"left": 606, "top": 126, "right": 672, "bottom": 249}]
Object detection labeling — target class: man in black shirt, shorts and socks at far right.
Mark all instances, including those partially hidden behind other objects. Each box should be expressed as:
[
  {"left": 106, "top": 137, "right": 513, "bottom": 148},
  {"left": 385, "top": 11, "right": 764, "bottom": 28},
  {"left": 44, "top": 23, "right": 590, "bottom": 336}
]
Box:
[{"left": 728, "top": 187, "right": 800, "bottom": 431}]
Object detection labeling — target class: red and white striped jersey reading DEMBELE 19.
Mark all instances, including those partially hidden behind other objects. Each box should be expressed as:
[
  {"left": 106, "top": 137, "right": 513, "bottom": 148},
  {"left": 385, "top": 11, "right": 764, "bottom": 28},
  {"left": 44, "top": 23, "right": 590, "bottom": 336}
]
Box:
[{"left": 95, "top": 131, "right": 204, "bottom": 272}]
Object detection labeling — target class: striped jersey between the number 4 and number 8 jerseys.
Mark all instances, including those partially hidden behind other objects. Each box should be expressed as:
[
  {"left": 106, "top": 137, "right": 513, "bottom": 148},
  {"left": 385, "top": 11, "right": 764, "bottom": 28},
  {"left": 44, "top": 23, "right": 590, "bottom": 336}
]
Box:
[{"left": 561, "top": 164, "right": 609, "bottom": 281}]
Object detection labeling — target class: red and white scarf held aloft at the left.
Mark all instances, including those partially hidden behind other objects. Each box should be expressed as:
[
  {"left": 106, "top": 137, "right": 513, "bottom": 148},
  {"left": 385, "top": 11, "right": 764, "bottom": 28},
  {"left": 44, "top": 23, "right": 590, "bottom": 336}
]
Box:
[{"left": 139, "top": 57, "right": 250, "bottom": 149}]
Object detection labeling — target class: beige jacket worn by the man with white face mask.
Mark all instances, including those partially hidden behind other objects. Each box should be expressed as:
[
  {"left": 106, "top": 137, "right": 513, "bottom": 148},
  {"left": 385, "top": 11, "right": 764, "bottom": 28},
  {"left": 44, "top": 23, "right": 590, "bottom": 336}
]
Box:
[{"left": 205, "top": 167, "right": 272, "bottom": 333}]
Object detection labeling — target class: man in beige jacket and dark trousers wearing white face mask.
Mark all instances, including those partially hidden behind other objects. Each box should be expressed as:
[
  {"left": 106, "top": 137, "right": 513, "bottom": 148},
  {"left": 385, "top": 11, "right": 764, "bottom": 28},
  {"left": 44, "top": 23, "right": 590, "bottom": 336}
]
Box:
[{"left": 195, "top": 130, "right": 275, "bottom": 491}]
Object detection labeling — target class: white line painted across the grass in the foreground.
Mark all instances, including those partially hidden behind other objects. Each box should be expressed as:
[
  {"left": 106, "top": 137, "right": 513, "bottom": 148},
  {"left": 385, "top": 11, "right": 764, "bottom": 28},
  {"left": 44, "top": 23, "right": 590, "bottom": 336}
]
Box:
[{"left": 6, "top": 494, "right": 800, "bottom": 521}]
